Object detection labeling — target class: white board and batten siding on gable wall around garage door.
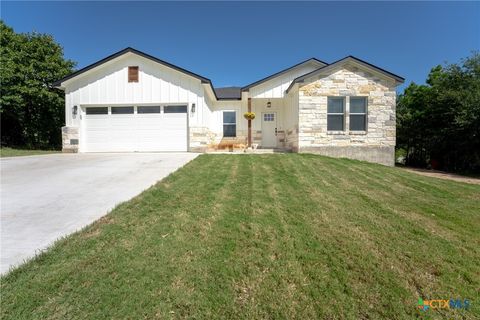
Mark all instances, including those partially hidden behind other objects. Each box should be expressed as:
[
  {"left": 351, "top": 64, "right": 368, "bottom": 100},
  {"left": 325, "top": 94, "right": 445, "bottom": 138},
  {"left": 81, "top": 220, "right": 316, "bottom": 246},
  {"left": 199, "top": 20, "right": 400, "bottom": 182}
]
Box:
[{"left": 65, "top": 53, "right": 209, "bottom": 127}]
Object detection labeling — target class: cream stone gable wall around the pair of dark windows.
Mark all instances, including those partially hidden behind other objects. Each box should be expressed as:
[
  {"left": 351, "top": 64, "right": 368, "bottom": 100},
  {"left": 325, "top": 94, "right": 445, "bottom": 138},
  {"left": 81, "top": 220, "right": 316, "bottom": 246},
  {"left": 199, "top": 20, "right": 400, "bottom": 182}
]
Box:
[{"left": 298, "top": 66, "right": 396, "bottom": 166}]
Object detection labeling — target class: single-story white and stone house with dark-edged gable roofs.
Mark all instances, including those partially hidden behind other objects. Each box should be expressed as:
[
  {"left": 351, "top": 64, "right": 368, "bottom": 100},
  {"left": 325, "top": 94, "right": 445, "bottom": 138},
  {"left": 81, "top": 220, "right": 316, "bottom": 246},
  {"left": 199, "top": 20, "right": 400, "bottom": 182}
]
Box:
[{"left": 53, "top": 48, "right": 404, "bottom": 165}]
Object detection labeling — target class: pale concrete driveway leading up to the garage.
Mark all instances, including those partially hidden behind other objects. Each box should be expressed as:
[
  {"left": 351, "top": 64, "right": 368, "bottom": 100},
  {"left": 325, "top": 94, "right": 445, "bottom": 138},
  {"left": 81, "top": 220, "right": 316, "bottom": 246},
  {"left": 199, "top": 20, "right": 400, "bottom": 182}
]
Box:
[{"left": 0, "top": 153, "right": 197, "bottom": 274}]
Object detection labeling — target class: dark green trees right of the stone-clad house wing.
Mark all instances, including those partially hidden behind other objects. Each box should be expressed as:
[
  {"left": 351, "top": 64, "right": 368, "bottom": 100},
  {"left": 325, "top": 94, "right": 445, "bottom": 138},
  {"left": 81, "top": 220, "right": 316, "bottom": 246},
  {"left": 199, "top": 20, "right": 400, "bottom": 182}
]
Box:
[{"left": 397, "top": 53, "right": 480, "bottom": 171}]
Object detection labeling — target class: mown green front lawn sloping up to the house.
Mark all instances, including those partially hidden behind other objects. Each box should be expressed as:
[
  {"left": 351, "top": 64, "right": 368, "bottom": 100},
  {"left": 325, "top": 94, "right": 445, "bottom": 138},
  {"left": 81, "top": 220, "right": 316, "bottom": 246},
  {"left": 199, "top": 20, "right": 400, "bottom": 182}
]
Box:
[{"left": 1, "top": 154, "right": 480, "bottom": 319}]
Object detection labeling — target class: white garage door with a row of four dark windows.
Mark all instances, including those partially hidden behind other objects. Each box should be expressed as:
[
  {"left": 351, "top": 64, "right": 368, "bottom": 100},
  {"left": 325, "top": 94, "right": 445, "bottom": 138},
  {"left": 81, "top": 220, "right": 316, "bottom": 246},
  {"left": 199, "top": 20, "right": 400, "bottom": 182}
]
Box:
[{"left": 80, "top": 106, "right": 187, "bottom": 152}]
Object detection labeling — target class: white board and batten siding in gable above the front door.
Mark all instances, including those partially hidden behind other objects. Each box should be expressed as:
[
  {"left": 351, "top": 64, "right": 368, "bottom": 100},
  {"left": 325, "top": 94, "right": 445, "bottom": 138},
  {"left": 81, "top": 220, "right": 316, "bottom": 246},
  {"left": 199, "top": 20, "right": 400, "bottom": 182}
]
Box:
[{"left": 249, "top": 63, "right": 319, "bottom": 98}]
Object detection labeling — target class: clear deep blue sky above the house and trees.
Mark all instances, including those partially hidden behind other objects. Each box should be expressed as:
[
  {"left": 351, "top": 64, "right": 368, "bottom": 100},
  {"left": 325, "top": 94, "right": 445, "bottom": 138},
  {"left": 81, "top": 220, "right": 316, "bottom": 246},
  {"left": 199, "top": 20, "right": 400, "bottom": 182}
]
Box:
[{"left": 1, "top": 1, "right": 480, "bottom": 90}]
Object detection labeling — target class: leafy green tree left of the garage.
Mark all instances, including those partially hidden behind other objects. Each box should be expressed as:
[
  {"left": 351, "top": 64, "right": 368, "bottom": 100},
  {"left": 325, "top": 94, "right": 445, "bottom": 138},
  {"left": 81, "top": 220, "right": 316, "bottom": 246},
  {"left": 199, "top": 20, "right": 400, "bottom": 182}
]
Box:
[{"left": 0, "top": 20, "right": 75, "bottom": 149}]
